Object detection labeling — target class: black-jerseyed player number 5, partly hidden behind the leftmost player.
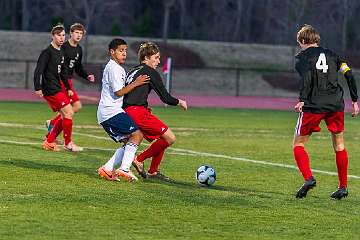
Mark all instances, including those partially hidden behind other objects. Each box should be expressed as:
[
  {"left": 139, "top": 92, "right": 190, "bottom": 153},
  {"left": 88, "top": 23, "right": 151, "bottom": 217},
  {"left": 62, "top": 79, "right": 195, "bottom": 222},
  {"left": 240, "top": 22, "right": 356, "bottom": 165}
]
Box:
[{"left": 46, "top": 23, "right": 95, "bottom": 136}]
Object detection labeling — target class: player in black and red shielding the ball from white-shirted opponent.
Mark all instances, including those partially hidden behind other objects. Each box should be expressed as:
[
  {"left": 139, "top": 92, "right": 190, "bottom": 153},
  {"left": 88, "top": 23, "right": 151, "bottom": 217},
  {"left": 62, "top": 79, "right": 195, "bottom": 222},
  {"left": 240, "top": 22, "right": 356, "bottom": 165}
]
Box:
[{"left": 124, "top": 42, "right": 187, "bottom": 180}]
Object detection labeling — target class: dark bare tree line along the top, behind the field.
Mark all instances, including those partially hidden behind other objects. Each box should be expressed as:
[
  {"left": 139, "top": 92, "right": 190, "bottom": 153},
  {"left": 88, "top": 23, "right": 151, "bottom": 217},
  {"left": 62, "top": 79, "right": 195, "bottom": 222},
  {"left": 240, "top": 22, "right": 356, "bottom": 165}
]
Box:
[{"left": 0, "top": 0, "right": 360, "bottom": 51}]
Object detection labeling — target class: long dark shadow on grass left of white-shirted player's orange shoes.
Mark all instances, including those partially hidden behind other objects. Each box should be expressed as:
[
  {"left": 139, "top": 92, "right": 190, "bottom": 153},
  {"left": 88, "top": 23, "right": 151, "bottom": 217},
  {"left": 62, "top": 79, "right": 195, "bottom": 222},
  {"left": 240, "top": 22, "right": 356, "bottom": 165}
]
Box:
[{"left": 0, "top": 159, "right": 98, "bottom": 178}]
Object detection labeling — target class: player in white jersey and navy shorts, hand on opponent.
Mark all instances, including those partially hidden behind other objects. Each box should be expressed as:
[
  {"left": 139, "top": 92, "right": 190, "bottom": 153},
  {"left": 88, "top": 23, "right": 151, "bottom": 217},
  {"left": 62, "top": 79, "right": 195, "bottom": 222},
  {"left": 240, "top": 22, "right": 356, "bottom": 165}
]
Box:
[{"left": 97, "top": 39, "right": 149, "bottom": 182}]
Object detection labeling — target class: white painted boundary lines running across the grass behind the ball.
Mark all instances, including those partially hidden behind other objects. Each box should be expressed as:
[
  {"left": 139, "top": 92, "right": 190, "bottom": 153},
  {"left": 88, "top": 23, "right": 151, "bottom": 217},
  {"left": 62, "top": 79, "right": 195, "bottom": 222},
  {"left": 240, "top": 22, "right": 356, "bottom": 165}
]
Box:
[{"left": 0, "top": 123, "right": 360, "bottom": 179}]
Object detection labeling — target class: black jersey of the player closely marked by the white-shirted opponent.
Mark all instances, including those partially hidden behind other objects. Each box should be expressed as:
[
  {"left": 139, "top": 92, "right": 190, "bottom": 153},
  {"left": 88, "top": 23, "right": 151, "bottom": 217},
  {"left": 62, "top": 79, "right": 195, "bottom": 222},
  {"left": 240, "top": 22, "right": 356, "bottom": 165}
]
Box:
[{"left": 123, "top": 64, "right": 179, "bottom": 108}]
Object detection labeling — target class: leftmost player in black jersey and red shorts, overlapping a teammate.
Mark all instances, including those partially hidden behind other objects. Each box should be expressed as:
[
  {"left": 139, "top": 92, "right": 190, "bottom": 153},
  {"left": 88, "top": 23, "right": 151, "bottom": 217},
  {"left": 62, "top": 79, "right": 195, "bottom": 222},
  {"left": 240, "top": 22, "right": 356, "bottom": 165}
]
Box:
[{"left": 34, "top": 25, "right": 82, "bottom": 152}]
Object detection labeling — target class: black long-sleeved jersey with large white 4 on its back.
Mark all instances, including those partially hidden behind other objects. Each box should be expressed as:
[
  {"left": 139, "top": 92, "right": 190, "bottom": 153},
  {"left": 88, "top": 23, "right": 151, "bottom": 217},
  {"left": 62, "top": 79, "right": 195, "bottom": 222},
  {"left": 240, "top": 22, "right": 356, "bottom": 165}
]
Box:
[{"left": 295, "top": 47, "right": 358, "bottom": 113}]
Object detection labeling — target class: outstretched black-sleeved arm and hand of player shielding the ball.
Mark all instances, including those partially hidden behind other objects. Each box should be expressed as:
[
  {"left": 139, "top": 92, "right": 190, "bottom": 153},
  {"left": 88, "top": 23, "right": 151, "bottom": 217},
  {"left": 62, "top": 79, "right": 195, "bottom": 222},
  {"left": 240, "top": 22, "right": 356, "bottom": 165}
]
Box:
[{"left": 150, "top": 70, "right": 187, "bottom": 110}]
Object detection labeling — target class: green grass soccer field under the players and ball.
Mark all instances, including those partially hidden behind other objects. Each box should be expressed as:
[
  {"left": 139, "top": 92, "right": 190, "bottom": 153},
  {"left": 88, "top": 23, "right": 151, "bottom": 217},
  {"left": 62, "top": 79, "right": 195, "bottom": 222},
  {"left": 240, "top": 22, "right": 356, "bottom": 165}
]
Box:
[{"left": 0, "top": 102, "right": 360, "bottom": 239}]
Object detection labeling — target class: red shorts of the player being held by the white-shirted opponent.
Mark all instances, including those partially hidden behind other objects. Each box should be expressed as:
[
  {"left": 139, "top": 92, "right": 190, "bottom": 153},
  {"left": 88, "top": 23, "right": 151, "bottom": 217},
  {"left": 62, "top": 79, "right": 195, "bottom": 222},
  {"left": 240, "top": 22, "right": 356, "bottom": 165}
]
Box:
[{"left": 125, "top": 106, "right": 169, "bottom": 142}]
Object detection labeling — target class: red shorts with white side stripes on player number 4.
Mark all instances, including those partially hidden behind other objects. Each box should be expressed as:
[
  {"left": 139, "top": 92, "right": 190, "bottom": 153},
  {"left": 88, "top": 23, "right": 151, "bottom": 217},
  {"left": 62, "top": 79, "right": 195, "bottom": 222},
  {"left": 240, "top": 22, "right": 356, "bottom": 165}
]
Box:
[{"left": 295, "top": 112, "right": 344, "bottom": 136}]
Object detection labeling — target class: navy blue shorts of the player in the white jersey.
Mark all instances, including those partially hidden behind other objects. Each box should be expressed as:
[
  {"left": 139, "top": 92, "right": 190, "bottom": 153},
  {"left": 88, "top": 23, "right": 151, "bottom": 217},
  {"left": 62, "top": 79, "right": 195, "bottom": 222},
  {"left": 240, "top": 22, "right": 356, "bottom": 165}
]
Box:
[{"left": 100, "top": 112, "right": 139, "bottom": 142}]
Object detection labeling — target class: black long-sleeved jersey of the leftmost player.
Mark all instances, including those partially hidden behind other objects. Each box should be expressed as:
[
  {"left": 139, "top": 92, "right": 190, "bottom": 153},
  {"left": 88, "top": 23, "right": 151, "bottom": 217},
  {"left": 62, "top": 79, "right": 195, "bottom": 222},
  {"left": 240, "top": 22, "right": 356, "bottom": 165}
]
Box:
[{"left": 34, "top": 44, "right": 70, "bottom": 96}]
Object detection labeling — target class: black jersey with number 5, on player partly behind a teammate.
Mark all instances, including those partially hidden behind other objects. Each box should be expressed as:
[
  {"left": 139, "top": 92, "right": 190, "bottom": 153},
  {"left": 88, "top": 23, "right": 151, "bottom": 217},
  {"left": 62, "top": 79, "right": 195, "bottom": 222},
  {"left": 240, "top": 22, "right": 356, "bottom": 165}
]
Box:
[{"left": 61, "top": 41, "right": 89, "bottom": 79}]
